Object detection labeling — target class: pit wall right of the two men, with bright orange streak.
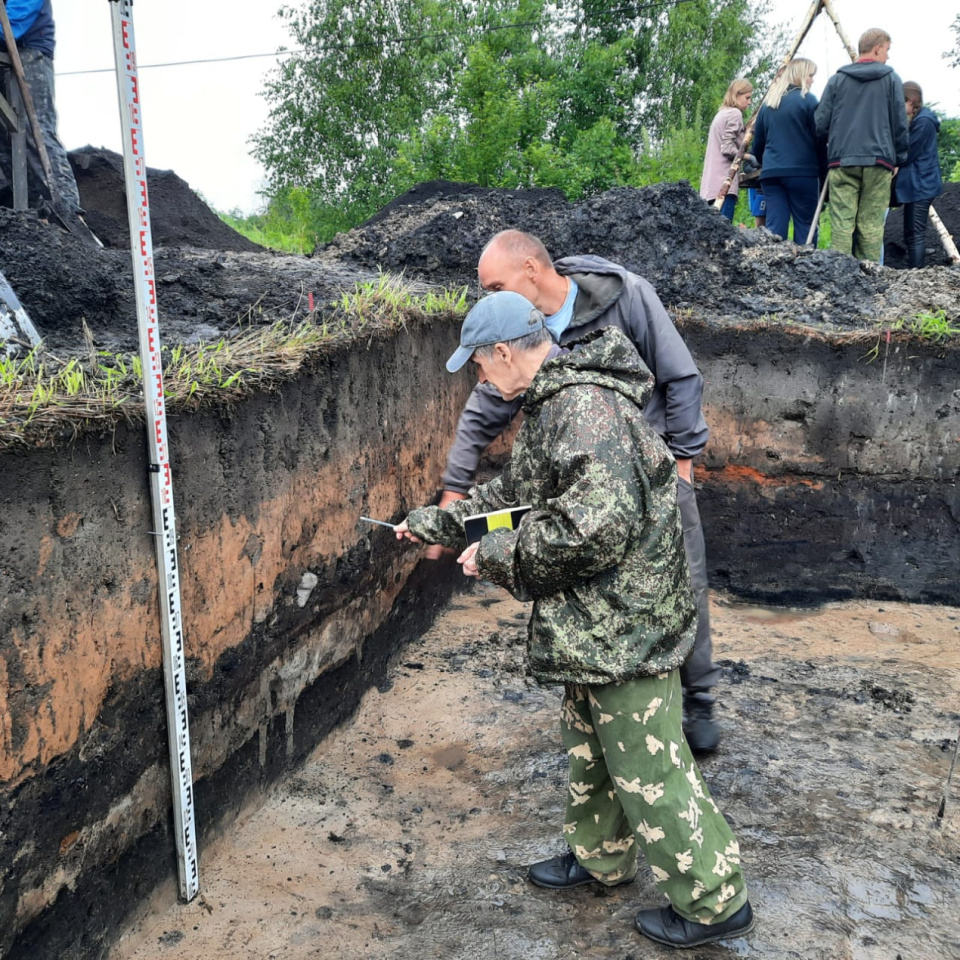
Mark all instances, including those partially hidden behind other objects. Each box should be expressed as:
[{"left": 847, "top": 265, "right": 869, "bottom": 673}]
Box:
[{"left": 681, "top": 322, "right": 960, "bottom": 605}]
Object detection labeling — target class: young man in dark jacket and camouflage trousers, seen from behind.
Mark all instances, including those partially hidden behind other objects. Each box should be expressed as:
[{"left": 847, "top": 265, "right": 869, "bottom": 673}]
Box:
[{"left": 814, "top": 27, "right": 908, "bottom": 261}]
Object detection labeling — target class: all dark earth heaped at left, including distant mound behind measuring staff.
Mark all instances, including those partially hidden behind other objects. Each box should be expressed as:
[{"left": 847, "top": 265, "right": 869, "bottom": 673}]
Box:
[{"left": 0, "top": 147, "right": 390, "bottom": 356}]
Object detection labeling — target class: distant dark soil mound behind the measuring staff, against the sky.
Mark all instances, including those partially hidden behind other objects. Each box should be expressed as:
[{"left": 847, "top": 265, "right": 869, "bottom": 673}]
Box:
[{"left": 69, "top": 147, "right": 261, "bottom": 252}]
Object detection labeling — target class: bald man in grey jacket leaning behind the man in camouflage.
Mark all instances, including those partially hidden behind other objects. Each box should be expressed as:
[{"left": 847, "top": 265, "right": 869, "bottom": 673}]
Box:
[{"left": 440, "top": 230, "right": 720, "bottom": 754}]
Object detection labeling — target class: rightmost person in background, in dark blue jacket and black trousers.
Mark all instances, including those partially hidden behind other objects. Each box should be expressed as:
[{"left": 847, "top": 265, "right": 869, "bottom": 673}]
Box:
[{"left": 894, "top": 81, "right": 943, "bottom": 268}]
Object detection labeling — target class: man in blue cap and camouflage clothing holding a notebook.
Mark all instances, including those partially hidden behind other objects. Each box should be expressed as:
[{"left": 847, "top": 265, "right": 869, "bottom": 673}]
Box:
[{"left": 396, "top": 292, "right": 753, "bottom": 947}]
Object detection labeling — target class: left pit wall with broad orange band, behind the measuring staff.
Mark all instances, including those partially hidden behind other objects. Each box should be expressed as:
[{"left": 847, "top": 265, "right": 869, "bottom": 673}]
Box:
[{"left": 0, "top": 323, "right": 471, "bottom": 960}]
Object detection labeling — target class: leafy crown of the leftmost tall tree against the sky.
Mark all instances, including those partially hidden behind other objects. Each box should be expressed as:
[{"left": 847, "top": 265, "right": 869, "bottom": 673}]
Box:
[{"left": 254, "top": 0, "right": 464, "bottom": 218}]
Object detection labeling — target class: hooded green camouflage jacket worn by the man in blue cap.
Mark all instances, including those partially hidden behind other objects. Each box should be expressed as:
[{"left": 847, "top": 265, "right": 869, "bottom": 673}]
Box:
[{"left": 407, "top": 327, "right": 696, "bottom": 684}]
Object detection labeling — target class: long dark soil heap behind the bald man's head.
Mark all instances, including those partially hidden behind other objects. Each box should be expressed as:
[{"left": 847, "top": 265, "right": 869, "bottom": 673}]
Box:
[{"left": 314, "top": 181, "right": 960, "bottom": 327}]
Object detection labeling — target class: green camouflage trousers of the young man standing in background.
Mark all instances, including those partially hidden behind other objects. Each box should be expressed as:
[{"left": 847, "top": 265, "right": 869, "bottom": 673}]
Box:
[{"left": 828, "top": 167, "right": 893, "bottom": 262}]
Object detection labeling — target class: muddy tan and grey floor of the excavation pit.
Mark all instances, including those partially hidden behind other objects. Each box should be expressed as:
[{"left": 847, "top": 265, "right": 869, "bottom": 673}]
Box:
[{"left": 117, "top": 585, "right": 960, "bottom": 960}]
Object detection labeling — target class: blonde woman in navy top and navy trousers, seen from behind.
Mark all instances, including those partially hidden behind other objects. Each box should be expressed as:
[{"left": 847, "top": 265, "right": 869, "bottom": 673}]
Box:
[{"left": 753, "top": 57, "right": 825, "bottom": 244}]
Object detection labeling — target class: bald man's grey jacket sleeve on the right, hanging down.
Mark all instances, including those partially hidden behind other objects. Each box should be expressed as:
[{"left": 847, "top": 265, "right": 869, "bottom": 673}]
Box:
[{"left": 625, "top": 278, "right": 710, "bottom": 459}]
